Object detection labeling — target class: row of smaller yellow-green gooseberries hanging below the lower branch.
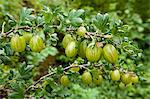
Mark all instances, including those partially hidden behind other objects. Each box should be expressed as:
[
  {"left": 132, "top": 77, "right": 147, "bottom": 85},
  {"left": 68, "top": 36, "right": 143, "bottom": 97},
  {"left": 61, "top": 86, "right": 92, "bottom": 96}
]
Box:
[{"left": 60, "top": 70, "right": 139, "bottom": 86}]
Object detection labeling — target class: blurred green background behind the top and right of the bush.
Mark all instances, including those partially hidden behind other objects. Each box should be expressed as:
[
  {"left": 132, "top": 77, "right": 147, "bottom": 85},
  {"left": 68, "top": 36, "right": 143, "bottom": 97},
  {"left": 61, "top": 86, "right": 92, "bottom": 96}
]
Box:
[{"left": 0, "top": 0, "right": 150, "bottom": 96}]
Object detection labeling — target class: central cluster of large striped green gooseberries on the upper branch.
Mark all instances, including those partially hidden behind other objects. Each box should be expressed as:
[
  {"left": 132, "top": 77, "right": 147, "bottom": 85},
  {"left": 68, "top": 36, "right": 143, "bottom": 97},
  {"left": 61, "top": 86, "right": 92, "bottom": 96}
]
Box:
[{"left": 62, "top": 26, "right": 118, "bottom": 63}]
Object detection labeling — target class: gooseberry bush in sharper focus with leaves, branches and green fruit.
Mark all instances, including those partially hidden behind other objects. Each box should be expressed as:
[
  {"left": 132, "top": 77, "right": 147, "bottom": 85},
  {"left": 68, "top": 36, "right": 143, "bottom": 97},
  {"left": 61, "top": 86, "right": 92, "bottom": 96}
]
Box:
[{"left": 0, "top": 7, "right": 143, "bottom": 99}]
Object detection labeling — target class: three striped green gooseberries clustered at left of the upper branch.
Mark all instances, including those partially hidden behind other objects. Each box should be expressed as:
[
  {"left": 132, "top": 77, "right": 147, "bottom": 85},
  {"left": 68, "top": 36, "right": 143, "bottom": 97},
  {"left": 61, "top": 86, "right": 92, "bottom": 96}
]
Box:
[{"left": 10, "top": 32, "right": 45, "bottom": 52}]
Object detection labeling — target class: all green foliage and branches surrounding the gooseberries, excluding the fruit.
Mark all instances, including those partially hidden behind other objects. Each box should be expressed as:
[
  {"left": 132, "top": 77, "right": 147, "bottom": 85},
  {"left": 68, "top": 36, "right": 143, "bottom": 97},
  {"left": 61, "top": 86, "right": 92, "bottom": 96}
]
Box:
[{"left": 0, "top": 0, "right": 150, "bottom": 99}]
